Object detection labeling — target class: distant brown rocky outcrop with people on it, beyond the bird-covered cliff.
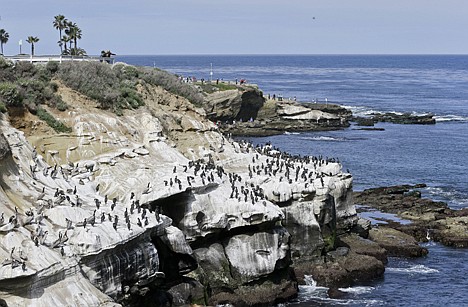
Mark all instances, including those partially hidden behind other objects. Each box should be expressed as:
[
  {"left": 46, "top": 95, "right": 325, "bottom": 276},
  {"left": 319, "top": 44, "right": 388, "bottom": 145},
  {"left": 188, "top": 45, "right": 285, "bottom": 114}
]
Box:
[{"left": 203, "top": 85, "right": 352, "bottom": 136}]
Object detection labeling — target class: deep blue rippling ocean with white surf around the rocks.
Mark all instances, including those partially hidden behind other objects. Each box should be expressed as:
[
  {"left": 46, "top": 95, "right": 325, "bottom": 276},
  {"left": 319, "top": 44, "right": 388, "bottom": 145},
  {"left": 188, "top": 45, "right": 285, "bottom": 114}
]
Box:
[{"left": 116, "top": 55, "right": 468, "bottom": 306}]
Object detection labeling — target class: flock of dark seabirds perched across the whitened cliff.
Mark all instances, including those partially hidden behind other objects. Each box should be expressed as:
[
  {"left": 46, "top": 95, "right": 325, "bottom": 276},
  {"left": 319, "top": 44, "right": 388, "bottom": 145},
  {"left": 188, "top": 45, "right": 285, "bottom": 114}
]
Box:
[{"left": 0, "top": 140, "right": 339, "bottom": 270}]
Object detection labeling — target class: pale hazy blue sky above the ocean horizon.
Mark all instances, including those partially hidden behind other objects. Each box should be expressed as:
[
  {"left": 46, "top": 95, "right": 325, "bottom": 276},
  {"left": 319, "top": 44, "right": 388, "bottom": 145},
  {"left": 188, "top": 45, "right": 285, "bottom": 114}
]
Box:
[{"left": 0, "top": 0, "right": 468, "bottom": 55}]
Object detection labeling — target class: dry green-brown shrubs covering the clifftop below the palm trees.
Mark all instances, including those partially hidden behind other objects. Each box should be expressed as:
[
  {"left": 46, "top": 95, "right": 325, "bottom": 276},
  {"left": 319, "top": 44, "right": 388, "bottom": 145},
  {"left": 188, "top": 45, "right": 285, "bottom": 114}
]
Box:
[{"left": 0, "top": 58, "right": 203, "bottom": 132}]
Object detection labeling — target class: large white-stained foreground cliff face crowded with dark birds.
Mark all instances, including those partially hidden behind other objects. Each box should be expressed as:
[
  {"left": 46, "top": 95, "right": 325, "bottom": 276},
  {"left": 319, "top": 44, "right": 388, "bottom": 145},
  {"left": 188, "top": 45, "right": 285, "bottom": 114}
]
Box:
[{"left": 0, "top": 76, "right": 355, "bottom": 306}]
